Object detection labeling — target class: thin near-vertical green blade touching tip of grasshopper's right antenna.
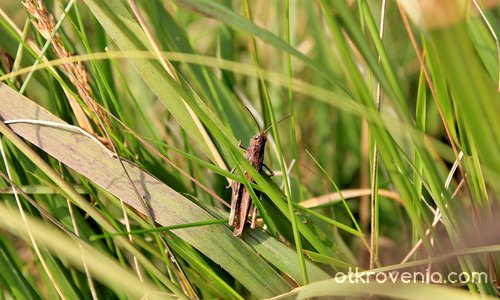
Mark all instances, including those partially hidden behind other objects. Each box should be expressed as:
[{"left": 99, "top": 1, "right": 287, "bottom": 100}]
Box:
[{"left": 285, "top": 0, "right": 304, "bottom": 202}]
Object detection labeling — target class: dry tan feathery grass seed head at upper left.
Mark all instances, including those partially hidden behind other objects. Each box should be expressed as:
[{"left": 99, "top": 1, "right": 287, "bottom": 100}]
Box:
[{"left": 24, "top": 0, "right": 110, "bottom": 144}]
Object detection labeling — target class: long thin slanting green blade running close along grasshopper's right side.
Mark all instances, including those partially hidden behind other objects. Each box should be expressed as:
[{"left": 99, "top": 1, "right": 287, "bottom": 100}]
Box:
[{"left": 244, "top": 0, "right": 309, "bottom": 285}]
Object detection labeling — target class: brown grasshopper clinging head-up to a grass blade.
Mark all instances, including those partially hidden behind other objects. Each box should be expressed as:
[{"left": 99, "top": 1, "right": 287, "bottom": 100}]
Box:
[{"left": 229, "top": 115, "right": 290, "bottom": 236}]
